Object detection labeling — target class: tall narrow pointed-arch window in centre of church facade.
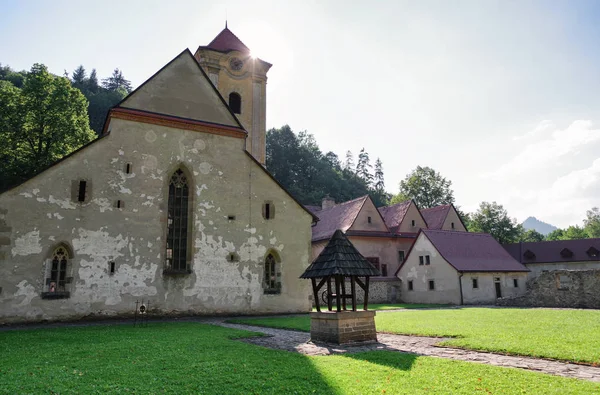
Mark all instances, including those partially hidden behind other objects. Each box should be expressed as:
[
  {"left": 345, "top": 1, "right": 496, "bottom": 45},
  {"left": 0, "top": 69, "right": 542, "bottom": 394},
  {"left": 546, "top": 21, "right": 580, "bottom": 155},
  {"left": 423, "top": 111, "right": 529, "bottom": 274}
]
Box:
[{"left": 166, "top": 169, "right": 190, "bottom": 272}]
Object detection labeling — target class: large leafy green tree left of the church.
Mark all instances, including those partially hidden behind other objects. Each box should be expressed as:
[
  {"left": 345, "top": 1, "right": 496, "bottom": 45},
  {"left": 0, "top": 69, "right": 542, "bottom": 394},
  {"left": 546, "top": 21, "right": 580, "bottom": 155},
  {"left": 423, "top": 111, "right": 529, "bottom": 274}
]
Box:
[{"left": 0, "top": 64, "right": 94, "bottom": 188}]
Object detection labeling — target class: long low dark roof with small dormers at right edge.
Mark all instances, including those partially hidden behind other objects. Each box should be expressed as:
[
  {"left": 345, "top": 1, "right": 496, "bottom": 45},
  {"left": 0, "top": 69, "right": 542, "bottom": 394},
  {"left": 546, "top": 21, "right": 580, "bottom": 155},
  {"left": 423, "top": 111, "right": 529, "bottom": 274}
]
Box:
[{"left": 504, "top": 239, "right": 600, "bottom": 263}]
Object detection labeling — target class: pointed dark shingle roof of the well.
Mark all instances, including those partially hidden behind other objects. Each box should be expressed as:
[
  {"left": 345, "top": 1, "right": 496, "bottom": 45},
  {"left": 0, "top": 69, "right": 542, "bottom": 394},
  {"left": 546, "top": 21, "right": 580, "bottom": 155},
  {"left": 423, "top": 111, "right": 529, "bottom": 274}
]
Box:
[{"left": 300, "top": 229, "right": 381, "bottom": 278}]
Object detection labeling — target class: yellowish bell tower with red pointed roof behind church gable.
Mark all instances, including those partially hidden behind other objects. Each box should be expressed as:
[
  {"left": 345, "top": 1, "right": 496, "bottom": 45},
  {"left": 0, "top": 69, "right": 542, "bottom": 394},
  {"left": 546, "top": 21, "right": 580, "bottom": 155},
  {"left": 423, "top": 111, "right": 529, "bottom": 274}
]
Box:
[{"left": 194, "top": 23, "right": 272, "bottom": 165}]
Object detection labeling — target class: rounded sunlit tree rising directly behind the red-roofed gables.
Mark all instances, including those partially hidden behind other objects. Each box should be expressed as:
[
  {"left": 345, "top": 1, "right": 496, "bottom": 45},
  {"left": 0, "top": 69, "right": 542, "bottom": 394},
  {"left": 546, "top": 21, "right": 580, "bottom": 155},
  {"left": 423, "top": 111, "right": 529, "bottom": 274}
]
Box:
[{"left": 392, "top": 166, "right": 454, "bottom": 209}]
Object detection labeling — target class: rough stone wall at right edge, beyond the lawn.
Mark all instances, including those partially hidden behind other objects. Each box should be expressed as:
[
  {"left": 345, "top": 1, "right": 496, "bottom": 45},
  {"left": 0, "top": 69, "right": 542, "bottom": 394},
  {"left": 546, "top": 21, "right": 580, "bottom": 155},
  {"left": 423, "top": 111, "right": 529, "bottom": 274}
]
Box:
[{"left": 496, "top": 270, "right": 600, "bottom": 309}]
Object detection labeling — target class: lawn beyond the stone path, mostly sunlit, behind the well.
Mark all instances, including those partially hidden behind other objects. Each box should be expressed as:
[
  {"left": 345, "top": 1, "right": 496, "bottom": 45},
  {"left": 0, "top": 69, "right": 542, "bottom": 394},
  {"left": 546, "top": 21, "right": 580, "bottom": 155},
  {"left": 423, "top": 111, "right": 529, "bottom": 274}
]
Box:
[{"left": 227, "top": 308, "right": 600, "bottom": 365}]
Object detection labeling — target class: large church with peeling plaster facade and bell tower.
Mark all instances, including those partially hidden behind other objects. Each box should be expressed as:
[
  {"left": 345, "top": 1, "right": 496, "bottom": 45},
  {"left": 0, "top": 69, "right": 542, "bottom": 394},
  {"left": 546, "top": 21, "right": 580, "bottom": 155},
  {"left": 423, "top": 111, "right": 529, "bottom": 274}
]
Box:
[{"left": 0, "top": 27, "right": 318, "bottom": 323}]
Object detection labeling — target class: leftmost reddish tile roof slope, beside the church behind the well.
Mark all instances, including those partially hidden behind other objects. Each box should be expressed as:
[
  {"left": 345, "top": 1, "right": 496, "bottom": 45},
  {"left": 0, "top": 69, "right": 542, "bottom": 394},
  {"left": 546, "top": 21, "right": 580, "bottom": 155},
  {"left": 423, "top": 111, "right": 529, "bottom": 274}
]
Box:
[{"left": 312, "top": 195, "right": 369, "bottom": 241}]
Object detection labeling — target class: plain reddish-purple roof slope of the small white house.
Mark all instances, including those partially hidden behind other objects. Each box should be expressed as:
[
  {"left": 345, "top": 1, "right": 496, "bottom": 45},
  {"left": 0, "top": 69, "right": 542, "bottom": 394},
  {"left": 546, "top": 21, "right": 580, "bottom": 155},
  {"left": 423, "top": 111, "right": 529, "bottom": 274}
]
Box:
[{"left": 409, "top": 230, "right": 529, "bottom": 272}]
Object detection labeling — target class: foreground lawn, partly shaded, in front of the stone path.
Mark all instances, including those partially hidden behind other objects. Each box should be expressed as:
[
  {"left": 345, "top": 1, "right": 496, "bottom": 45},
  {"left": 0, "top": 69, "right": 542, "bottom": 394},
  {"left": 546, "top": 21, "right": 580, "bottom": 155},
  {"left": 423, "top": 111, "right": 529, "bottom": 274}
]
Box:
[{"left": 0, "top": 323, "right": 600, "bottom": 394}]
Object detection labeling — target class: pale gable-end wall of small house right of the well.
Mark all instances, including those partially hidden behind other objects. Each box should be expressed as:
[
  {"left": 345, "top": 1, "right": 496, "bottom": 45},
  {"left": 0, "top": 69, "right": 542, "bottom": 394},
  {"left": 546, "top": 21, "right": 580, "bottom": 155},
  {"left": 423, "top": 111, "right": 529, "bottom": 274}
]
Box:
[{"left": 397, "top": 233, "right": 460, "bottom": 304}]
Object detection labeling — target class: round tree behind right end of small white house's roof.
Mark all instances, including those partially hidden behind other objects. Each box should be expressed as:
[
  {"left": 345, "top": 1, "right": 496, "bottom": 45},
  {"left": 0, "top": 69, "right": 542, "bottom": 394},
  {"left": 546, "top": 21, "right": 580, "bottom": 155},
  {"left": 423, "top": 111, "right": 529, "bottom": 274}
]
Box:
[{"left": 469, "top": 202, "right": 523, "bottom": 244}]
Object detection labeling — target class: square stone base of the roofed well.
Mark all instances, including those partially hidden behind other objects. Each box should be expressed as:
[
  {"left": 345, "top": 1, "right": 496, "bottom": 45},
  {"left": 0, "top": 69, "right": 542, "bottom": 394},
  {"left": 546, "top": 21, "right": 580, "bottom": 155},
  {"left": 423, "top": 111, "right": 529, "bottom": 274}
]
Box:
[{"left": 310, "top": 310, "right": 377, "bottom": 344}]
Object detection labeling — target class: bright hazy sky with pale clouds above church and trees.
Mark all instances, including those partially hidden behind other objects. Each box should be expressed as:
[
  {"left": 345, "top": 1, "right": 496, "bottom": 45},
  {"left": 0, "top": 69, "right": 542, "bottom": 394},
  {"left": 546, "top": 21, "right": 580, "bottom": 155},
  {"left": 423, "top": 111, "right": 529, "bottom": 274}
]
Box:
[{"left": 0, "top": 0, "right": 600, "bottom": 227}]
